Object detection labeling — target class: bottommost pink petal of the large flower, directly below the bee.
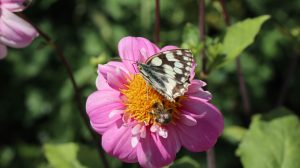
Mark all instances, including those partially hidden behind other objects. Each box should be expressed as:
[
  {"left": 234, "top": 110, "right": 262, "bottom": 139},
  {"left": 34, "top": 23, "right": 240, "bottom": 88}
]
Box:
[{"left": 137, "top": 128, "right": 181, "bottom": 168}]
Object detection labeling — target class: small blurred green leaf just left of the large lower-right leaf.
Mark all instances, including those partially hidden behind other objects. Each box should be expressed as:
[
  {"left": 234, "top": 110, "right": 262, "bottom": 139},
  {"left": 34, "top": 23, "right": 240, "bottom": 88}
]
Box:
[{"left": 222, "top": 126, "right": 247, "bottom": 143}]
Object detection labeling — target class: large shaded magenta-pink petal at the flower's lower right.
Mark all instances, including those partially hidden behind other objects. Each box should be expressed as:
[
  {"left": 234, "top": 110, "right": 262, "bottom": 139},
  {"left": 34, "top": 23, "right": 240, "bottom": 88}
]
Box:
[{"left": 177, "top": 98, "right": 224, "bottom": 152}]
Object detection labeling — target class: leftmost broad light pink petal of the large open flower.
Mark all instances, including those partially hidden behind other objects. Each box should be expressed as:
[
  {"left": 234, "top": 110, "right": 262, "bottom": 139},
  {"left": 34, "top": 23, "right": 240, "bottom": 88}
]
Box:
[{"left": 86, "top": 89, "right": 124, "bottom": 134}]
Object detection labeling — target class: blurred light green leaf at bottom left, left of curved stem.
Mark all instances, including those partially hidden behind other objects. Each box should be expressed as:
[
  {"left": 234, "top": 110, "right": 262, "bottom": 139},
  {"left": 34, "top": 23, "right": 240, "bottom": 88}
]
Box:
[{"left": 43, "top": 143, "right": 85, "bottom": 168}]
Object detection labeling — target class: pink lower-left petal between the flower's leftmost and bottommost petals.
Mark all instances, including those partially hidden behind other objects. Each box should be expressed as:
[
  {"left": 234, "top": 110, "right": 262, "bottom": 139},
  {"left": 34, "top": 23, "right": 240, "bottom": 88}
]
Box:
[{"left": 102, "top": 120, "right": 137, "bottom": 163}]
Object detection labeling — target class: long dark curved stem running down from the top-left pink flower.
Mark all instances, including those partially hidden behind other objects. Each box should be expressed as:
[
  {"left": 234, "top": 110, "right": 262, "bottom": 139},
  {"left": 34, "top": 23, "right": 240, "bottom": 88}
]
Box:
[{"left": 18, "top": 13, "right": 110, "bottom": 168}]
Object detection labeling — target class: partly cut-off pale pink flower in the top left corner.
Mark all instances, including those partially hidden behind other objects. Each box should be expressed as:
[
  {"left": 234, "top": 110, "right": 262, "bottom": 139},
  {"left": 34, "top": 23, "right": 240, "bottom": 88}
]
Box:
[{"left": 0, "top": 0, "right": 38, "bottom": 59}]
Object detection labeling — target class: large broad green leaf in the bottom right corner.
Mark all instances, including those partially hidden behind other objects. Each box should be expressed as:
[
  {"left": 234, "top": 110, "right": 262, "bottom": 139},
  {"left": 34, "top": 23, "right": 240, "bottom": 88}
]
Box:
[{"left": 237, "top": 108, "right": 300, "bottom": 168}]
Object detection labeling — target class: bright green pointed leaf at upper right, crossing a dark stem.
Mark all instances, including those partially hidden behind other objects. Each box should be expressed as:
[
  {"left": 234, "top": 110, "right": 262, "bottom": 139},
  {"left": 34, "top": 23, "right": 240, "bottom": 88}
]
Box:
[{"left": 223, "top": 15, "right": 270, "bottom": 61}]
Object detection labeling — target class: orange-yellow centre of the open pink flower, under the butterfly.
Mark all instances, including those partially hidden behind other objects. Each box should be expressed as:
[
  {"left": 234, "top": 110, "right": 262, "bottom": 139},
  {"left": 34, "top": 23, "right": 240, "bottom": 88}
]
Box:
[{"left": 121, "top": 74, "right": 181, "bottom": 125}]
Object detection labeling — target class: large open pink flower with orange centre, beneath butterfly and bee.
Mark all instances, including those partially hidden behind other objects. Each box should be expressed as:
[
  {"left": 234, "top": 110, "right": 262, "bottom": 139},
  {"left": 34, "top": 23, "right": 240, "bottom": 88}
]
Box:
[{"left": 86, "top": 37, "right": 224, "bottom": 168}]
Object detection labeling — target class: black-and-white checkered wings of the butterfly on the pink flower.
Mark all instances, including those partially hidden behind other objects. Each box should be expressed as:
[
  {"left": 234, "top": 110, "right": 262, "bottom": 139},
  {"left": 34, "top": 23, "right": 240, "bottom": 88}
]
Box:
[{"left": 137, "top": 49, "right": 194, "bottom": 102}]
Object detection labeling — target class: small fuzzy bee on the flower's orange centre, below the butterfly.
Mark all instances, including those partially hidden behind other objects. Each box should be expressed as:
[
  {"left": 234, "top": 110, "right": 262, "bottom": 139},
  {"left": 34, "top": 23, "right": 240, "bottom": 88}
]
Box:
[{"left": 150, "top": 103, "right": 172, "bottom": 125}]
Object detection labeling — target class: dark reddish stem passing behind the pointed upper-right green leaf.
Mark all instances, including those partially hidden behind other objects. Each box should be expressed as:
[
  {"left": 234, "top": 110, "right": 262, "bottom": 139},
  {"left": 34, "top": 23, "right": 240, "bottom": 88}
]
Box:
[{"left": 220, "top": 0, "right": 251, "bottom": 122}]
